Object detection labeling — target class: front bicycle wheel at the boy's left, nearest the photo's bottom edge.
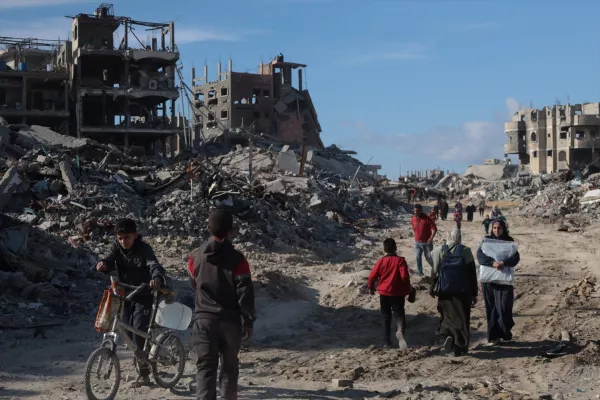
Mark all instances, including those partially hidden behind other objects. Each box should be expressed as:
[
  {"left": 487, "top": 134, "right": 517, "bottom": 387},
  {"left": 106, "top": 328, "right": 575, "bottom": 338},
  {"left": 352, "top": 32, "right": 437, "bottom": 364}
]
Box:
[{"left": 84, "top": 347, "right": 121, "bottom": 400}]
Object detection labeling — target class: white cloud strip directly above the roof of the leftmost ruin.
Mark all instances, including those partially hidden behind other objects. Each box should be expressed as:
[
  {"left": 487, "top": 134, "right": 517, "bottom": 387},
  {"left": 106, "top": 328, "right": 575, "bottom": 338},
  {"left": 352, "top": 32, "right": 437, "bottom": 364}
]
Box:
[{"left": 0, "top": 18, "right": 71, "bottom": 40}]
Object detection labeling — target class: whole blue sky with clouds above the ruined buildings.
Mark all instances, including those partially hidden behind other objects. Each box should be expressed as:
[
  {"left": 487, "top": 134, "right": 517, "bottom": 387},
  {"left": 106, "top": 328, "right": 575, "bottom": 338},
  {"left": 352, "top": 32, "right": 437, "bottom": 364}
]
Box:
[{"left": 0, "top": 0, "right": 600, "bottom": 177}]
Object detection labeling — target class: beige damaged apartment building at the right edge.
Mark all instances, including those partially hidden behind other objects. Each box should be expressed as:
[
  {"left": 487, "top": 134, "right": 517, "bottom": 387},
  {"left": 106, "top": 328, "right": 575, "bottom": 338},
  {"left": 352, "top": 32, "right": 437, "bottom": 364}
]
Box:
[{"left": 504, "top": 103, "right": 600, "bottom": 175}]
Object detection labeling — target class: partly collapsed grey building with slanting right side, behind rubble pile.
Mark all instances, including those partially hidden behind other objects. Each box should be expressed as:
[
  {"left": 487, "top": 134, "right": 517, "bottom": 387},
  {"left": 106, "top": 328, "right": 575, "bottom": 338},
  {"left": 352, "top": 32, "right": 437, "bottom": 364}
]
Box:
[{"left": 191, "top": 55, "right": 323, "bottom": 148}]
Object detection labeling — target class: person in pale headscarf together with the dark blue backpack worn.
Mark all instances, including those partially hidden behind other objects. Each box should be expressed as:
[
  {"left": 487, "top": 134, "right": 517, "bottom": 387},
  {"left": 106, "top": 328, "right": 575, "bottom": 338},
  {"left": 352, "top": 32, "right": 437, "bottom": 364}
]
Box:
[{"left": 431, "top": 228, "right": 478, "bottom": 357}]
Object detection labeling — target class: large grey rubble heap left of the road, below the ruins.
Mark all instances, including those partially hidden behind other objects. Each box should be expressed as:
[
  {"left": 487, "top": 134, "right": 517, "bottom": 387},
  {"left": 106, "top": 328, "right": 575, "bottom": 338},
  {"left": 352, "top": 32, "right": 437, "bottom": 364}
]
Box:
[{"left": 0, "top": 122, "right": 410, "bottom": 312}]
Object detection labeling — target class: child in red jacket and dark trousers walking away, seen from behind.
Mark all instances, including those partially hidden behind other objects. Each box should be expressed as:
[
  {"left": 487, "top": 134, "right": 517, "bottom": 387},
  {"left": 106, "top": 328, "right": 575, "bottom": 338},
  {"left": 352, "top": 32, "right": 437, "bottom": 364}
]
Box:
[{"left": 368, "top": 238, "right": 412, "bottom": 350}]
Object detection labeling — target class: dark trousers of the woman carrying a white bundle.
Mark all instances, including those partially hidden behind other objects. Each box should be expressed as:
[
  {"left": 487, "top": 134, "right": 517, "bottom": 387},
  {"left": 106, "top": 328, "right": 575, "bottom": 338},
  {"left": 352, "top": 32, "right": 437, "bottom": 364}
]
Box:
[{"left": 481, "top": 283, "right": 515, "bottom": 342}]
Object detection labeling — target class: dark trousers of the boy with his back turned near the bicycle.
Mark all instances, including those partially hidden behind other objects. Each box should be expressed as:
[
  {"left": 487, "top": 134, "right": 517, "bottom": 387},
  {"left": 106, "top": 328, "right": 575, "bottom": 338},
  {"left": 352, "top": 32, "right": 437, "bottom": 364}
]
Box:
[{"left": 193, "top": 319, "right": 242, "bottom": 400}]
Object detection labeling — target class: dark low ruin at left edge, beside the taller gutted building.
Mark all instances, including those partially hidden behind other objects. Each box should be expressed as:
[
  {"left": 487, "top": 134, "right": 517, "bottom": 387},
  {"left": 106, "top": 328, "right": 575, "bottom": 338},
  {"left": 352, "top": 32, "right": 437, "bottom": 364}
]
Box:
[{"left": 0, "top": 37, "right": 71, "bottom": 134}]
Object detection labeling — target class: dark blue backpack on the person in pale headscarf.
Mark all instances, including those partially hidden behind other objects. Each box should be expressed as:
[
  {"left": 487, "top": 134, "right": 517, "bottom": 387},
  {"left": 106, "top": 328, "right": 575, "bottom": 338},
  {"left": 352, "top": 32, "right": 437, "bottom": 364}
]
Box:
[{"left": 438, "top": 244, "right": 469, "bottom": 294}]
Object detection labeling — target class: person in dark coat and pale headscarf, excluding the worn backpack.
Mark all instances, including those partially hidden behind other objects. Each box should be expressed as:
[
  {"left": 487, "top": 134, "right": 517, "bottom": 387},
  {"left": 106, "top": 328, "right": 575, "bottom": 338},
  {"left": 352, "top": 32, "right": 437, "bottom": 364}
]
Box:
[{"left": 431, "top": 228, "right": 479, "bottom": 357}]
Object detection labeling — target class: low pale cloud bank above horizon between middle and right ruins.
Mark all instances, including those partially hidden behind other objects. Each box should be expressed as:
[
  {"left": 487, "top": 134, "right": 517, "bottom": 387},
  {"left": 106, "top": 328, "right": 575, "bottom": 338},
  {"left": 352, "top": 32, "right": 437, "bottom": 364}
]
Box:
[{"left": 344, "top": 97, "right": 519, "bottom": 166}]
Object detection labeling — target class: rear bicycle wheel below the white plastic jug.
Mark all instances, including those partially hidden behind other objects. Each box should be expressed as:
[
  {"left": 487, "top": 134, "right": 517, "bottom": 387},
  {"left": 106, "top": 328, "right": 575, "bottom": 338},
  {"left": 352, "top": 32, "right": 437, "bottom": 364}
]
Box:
[{"left": 150, "top": 333, "right": 186, "bottom": 389}]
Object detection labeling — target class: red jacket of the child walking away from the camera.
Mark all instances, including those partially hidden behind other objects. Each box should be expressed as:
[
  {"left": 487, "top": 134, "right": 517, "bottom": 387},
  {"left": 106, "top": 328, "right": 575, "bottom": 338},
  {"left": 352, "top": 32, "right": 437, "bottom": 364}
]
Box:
[{"left": 369, "top": 255, "right": 411, "bottom": 296}]
